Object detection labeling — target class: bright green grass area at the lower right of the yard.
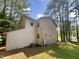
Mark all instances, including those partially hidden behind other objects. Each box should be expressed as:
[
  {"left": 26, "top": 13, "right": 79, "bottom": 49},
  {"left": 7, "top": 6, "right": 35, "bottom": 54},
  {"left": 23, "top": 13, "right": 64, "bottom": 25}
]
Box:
[{"left": 48, "top": 43, "right": 79, "bottom": 59}]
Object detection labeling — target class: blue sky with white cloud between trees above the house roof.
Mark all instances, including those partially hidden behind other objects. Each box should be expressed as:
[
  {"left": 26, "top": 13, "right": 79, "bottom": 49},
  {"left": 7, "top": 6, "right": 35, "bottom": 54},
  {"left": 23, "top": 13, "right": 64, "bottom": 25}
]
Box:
[{"left": 29, "top": 0, "right": 48, "bottom": 19}]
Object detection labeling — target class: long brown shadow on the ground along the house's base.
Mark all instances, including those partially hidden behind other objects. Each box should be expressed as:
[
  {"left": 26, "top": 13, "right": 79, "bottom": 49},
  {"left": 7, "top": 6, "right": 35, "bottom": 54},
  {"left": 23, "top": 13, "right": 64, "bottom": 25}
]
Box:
[{"left": 0, "top": 46, "right": 52, "bottom": 58}]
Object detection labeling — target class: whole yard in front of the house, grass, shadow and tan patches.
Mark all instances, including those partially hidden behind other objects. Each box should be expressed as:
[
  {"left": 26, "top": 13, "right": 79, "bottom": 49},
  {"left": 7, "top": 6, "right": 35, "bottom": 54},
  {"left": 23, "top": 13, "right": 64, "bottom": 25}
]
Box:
[{"left": 0, "top": 43, "right": 79, "bottom": 59}]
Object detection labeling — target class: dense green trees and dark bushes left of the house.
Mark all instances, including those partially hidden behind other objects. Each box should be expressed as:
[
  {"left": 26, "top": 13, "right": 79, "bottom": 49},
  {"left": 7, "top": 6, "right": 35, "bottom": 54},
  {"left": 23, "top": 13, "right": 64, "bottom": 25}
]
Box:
[{"left": 0, "top": 0, "right": 27, "bottom": 32}]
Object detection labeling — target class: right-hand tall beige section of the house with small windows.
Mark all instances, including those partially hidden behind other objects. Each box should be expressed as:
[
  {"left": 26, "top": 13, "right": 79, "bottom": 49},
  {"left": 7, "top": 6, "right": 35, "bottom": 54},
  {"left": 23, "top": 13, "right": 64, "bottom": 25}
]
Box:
[{"left": 37, "top": 17, "right": 57, "bottom": 45}]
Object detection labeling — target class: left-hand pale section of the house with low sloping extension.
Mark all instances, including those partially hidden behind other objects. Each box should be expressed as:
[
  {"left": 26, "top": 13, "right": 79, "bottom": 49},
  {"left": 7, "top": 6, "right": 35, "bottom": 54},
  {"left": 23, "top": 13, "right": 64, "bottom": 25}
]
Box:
[{"left": 6, "top": 15, "right": 36, "bottom": 51}]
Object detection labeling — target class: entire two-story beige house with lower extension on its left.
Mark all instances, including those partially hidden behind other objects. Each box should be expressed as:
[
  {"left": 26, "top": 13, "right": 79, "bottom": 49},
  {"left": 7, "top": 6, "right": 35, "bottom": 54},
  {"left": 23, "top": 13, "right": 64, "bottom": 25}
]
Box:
[{"left": 6, "top": 15, "right": 57, "bottom": 51}]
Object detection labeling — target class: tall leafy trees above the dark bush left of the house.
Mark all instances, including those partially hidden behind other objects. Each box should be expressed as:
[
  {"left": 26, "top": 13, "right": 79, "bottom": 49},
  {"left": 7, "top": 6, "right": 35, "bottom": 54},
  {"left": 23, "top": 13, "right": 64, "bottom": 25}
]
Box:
[{"left": 0, "top": 0, "right": 28, "bottom": 29}]
